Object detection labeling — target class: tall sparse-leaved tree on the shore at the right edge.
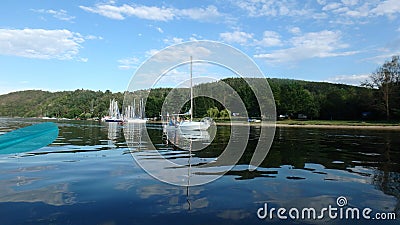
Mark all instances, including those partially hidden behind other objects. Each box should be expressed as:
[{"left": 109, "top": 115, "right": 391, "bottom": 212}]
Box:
[{"left": 362, "top": 56, "right": 400, "bottom": 120}]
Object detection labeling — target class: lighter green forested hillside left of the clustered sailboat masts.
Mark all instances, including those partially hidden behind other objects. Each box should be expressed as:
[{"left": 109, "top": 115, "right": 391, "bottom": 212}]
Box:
[{"left": 0, "top": 90, "right": 123, "bottom": 119}]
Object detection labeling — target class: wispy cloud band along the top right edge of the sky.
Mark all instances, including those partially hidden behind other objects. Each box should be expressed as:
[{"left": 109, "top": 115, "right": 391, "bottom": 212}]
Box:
[{"left": 230, "top": 0, "right": 400, "bottom": 25}]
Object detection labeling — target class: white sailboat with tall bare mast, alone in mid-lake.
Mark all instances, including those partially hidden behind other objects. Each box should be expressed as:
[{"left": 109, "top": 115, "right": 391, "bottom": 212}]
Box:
[{"left": 168, "top": 57, "right": 211, "bottom": 131}]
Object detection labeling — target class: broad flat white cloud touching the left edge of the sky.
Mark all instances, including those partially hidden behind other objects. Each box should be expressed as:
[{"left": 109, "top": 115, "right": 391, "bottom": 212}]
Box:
[{"left": 0, "top": 29, "right": 85, "bottom": 60}]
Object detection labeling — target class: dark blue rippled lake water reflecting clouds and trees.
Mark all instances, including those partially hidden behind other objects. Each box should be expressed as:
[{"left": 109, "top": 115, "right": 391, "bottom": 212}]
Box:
[{"left": 0, "top": 119, "right": 400, "bottom": 225}]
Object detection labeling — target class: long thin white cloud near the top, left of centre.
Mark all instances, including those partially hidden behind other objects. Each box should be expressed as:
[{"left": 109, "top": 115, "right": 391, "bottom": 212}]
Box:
[{"left": 79, "top": 2, "right": 223, "bottom": 21}]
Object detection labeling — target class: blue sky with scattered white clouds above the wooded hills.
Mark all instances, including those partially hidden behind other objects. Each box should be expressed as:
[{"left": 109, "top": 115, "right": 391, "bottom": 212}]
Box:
[{"left": 0, "top": 0, "right": 400, "bottom": 94}]
